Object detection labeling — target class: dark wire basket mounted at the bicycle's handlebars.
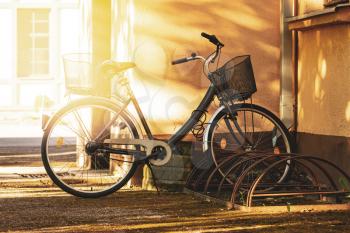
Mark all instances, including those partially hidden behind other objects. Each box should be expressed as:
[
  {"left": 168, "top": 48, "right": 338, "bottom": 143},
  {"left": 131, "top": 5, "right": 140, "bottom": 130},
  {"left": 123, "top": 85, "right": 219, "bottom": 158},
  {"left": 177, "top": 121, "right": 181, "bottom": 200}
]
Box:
[{"left": 209, "top": 55, "right": 257, "bottom": 102}]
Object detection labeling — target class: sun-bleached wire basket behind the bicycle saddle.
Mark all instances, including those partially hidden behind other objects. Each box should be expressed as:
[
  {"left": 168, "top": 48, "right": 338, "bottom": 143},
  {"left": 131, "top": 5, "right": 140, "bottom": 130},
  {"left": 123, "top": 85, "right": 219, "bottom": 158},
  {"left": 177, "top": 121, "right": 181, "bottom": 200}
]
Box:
[{"left": 63, "top": 53, "right": 93, "bottom": 95}]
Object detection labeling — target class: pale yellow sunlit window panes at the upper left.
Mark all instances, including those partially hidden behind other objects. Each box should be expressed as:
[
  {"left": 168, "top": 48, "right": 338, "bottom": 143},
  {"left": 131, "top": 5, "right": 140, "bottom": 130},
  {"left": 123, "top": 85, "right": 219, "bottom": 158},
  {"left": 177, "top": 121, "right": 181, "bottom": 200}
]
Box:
[{"left": 17, "top": 8, "right": 50, "bottom": 78}]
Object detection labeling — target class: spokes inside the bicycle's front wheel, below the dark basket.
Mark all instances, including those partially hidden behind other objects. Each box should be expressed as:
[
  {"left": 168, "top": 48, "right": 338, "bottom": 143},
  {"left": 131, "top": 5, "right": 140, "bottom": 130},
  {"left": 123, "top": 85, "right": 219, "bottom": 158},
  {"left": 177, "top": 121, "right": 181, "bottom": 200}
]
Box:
[{"left": 207, "top": 107, "right": 290, "bottom": 191}]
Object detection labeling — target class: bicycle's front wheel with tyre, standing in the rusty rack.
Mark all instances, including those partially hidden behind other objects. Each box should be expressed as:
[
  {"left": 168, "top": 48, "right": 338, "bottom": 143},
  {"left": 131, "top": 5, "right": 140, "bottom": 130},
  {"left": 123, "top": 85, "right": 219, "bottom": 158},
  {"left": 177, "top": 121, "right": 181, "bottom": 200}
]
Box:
[{"left": 207, "top": 103, "right": 293, "bottom": 183}]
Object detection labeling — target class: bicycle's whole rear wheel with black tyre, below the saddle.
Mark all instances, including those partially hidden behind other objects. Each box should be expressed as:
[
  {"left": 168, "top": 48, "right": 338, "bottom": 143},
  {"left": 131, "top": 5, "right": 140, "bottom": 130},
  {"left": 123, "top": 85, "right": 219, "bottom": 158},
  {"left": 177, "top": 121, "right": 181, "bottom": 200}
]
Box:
[{"left": 41, "top": 98, "right": 139, "bottom": 198}]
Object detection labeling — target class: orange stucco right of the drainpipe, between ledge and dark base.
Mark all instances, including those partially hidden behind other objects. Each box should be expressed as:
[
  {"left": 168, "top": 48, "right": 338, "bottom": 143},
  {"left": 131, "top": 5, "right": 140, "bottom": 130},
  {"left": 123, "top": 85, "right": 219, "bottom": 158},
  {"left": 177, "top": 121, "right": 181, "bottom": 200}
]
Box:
[{"left": 298, "top": 25, "right": 350, "bottom": 136}]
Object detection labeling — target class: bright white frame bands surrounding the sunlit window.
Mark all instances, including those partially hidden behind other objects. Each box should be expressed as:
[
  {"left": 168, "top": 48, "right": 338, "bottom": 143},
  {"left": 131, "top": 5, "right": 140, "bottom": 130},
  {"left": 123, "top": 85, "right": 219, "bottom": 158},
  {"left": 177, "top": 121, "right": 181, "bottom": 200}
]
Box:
[{"left": 0, "top": 0, "right": 80, "bottom": 110}]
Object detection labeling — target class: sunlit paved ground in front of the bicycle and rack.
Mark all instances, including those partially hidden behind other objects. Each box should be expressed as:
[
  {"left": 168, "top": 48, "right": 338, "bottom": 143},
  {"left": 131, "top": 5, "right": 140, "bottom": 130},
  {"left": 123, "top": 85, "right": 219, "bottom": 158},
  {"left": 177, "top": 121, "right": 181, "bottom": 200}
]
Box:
[{"left": 0, "top": 156, "right": 350, "bottom": 233}]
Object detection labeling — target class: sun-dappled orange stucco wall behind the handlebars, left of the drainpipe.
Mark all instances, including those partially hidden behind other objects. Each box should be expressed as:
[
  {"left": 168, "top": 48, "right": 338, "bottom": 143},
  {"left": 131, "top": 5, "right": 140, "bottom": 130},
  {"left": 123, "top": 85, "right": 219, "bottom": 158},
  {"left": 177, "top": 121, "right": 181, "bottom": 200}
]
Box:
[{"left": 134, "top": 0, "right": 280, "bottom": 134}]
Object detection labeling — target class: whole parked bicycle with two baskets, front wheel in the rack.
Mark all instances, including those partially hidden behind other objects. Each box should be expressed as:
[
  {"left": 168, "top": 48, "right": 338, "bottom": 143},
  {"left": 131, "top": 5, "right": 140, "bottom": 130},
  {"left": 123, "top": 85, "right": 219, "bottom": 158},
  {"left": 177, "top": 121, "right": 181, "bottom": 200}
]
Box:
[{"left": 41, "top": 33, "right": 292, "bottom": 198}]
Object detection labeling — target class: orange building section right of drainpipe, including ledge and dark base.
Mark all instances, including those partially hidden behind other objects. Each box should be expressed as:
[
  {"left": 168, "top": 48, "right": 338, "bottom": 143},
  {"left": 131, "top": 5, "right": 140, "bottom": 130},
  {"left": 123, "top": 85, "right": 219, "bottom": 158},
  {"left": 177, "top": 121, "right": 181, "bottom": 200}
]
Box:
[{"left": 289, "top": 0, "right": 350, "bottom": 170}]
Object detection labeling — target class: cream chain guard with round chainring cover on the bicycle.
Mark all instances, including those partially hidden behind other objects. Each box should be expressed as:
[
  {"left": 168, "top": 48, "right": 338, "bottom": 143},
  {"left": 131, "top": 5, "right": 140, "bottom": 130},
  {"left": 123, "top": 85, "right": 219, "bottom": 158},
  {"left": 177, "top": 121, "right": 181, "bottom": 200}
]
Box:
[{"left": 103, "top": 138, "right": 172, "bottom": 166}]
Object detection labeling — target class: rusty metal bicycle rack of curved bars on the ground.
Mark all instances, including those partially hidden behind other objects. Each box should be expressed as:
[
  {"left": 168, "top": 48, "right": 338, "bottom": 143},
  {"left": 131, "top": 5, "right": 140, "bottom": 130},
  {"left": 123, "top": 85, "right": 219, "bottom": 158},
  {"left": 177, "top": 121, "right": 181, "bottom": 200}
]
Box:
[{"left": 187, "top": 152, "right": 350, "bottom": 208}]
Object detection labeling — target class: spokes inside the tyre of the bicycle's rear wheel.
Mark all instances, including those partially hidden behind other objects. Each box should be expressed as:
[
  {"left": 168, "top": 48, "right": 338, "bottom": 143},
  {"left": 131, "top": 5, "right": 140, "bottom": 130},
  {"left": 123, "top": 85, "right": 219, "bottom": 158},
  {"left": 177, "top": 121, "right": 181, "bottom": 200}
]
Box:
[{"left": 42, "top": 102, "right": 136, "bottom": 195}]
